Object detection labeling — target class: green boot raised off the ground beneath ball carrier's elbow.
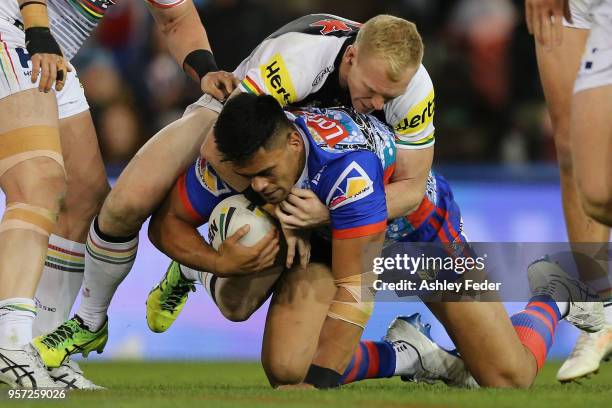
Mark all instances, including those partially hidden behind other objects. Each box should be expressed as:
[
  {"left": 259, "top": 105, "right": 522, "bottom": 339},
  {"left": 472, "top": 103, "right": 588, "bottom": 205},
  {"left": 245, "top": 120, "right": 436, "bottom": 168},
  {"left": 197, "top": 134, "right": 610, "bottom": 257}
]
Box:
[{"left": 147, "top": 261, "right": 195, "bottom": 333}]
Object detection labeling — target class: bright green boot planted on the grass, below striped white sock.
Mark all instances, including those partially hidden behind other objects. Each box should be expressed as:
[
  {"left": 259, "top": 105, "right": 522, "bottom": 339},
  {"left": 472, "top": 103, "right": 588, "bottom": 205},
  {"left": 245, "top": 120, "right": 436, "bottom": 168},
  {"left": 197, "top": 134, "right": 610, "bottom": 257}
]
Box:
[{"left": 32, "top": 315, "right": 108, "bottom": 368}]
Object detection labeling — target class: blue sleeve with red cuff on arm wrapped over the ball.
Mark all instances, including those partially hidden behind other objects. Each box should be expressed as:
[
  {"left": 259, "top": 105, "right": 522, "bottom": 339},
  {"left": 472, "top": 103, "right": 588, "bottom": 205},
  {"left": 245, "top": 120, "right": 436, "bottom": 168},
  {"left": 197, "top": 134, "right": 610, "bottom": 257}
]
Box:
[{"left": 177, "top": 157, "right": 237, "bottom": 224}]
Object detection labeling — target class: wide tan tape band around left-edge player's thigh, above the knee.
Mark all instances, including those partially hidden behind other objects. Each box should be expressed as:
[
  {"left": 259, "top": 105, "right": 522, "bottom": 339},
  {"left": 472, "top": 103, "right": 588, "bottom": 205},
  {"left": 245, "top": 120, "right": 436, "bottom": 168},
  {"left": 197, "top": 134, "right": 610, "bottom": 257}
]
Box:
[{"left": 0, "top": 126, "right": 64, "bottom": 177}]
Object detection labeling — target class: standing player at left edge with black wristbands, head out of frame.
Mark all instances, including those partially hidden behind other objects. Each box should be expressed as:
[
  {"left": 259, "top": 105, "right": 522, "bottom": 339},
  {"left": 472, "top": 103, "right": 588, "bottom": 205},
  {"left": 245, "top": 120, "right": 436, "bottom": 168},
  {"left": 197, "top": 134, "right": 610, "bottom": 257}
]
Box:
[{"left": 0, "top": 0, "right": 231, "bottom": 388}]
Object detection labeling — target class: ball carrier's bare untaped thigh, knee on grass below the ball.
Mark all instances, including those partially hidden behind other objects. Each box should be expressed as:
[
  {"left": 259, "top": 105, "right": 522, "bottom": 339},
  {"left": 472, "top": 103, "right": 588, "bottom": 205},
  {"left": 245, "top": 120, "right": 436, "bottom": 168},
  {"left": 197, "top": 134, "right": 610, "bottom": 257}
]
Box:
[{"left": 262, "top": 263, "right": 336, "bottom": 386}]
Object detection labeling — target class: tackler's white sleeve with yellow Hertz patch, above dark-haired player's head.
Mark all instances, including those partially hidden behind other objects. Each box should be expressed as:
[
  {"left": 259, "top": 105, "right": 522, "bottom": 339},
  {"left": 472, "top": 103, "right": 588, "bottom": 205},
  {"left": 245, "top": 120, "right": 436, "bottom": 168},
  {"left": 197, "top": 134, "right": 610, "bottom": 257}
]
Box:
[{"left": 234, "top": 33, "right": 320, "bottom": 106}]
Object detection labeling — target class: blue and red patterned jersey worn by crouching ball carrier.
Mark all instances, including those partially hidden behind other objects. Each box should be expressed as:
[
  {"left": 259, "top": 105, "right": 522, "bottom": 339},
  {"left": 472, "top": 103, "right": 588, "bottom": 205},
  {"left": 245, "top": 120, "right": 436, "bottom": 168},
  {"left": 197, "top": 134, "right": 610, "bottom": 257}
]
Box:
[{"left": 178, "top": 108, "right": 395, "bottom": 239}]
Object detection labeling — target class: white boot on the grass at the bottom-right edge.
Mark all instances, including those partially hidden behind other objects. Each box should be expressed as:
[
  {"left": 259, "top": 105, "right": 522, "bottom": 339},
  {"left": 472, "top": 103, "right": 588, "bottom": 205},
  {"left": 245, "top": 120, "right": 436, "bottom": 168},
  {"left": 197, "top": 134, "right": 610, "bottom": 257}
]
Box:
[{"left": 557, "top": 325, "right": 612, "bottom": 383}]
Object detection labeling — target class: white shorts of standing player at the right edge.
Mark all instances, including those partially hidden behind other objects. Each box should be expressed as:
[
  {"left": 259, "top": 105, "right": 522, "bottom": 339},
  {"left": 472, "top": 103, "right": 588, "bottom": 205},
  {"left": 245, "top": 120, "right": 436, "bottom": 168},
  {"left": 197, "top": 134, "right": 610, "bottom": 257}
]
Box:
[{"left": 574, "top": 0, "right": 612, "bottom": 93}]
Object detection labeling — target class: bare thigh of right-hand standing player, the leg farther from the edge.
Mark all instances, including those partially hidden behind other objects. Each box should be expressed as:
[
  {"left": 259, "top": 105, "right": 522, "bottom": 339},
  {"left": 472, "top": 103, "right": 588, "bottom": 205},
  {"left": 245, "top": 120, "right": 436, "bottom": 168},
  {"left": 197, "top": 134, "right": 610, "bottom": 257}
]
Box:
[{"left": 535, "top": 27, "right": 589, "bottom": 160}]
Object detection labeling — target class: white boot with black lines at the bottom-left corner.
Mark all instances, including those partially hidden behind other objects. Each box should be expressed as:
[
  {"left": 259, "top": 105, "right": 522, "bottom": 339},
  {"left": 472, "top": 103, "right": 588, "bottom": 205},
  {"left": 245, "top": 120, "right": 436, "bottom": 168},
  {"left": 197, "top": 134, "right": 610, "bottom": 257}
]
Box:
[{"left": 0, "top": 344, "right": 62, "bottom": 389}]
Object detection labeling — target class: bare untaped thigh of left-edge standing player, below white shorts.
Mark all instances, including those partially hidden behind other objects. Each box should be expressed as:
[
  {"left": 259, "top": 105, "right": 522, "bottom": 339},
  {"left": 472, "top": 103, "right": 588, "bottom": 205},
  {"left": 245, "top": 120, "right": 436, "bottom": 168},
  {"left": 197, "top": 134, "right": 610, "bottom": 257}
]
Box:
[{"left": 59, "top": 110, "right": 110, "bottom": 207}]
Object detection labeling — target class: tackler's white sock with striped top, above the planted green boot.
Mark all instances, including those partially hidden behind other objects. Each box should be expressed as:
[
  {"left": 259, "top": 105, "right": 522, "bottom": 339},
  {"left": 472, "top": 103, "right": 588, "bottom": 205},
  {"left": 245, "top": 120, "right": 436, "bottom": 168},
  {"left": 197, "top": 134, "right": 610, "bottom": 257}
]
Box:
[{"left": 76, "top": 220, "right": 138, "bottom": 331}]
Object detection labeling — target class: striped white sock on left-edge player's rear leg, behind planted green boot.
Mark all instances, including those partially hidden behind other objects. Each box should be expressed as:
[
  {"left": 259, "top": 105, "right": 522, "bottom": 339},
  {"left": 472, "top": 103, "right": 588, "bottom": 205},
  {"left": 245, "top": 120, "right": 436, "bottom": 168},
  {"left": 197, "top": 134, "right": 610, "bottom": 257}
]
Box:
[{"left": 33, "top": 235, "right": 85, "bottom": 336}]
